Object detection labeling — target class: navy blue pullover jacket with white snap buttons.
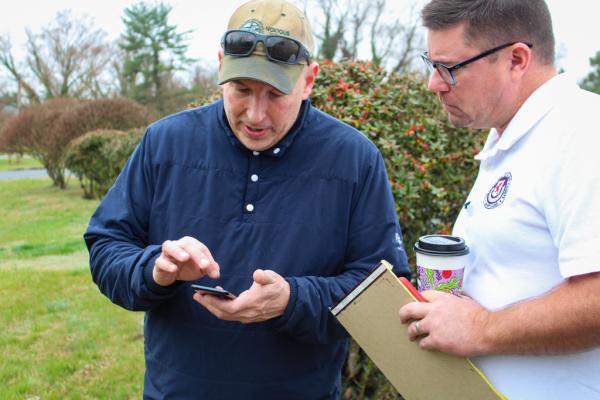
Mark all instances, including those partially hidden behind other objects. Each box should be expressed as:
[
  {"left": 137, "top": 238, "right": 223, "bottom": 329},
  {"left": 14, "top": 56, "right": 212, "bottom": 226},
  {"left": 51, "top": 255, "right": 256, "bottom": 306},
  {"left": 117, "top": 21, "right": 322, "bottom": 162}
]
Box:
[{"left": 84, "top": 100, "right": 408, "bottom": 400}]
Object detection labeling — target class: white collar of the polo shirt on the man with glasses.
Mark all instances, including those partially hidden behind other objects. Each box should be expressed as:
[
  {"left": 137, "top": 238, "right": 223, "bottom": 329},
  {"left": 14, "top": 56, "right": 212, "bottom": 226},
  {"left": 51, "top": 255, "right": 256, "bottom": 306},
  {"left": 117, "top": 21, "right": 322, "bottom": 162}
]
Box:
[{"left": 475, "top": 74, "right": 576, "bottom": 161}]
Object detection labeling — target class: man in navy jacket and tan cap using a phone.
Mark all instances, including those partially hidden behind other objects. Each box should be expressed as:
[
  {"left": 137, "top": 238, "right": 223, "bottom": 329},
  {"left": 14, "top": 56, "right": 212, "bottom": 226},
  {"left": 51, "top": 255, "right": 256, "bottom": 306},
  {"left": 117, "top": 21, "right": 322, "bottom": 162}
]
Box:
[{"left": 85, "top": 0, "right": 408, "bottom": 400}]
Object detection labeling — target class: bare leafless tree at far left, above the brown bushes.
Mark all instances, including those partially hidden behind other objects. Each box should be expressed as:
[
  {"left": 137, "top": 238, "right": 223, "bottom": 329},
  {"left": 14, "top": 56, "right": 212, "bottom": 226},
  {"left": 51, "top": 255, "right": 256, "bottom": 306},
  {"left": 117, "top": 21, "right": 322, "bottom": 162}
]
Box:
[{"left": 0, "top": 11, "right": 113, "bottom": 103}]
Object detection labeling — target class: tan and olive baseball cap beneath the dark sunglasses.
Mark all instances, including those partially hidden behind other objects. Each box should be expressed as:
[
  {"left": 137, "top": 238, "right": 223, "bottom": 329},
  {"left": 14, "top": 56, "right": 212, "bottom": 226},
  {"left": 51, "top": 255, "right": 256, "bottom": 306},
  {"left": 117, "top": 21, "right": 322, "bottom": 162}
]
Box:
[{"left": 219, "top": 0, "right": 314, "bottom": 94}]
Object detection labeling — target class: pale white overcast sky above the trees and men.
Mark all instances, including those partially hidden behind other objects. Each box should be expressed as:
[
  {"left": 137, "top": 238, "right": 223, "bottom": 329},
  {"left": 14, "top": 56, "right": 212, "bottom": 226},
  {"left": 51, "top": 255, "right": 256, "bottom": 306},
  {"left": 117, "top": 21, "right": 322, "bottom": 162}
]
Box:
[{"left": 0, "top": 0, "right": 600, "bottom": 79}]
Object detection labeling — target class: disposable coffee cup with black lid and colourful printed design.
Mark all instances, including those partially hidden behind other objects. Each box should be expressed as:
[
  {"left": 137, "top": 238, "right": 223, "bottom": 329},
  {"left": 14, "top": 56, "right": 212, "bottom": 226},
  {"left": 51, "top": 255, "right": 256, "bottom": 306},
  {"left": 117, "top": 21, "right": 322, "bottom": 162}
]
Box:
[{"left": 415, "top": 235, "right": 469, "bottom": 294}]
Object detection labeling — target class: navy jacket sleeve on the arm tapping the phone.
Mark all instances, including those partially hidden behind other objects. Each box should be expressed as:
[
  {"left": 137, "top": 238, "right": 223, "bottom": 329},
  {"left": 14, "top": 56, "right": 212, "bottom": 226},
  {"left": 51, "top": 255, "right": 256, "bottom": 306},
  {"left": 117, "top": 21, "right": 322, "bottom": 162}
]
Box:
[{"left": 84, "top": 130, "right": 180, "bottom": 311}]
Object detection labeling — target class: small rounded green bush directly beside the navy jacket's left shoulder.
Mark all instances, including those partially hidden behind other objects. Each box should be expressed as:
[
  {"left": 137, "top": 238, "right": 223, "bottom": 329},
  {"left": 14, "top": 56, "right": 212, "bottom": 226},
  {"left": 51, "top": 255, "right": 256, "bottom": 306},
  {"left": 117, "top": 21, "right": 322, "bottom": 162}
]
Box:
[{"left": 65, "top": 128, "right": 143, "bottom": 198}]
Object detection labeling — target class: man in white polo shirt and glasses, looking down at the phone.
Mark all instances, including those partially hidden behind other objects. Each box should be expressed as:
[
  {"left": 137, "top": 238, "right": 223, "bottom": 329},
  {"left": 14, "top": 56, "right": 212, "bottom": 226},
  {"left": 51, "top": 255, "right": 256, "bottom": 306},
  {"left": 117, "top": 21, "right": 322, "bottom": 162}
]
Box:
[{"left": 400, "top": 0, "right": 600, "bottom": 400}]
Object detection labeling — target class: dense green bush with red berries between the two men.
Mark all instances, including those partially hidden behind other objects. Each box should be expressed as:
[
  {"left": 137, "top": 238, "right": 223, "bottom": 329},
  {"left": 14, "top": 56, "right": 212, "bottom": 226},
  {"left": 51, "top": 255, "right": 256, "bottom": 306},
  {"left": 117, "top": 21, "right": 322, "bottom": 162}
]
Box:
[{"left": 311, "top": 61, "right": 484, "bottom": 400}]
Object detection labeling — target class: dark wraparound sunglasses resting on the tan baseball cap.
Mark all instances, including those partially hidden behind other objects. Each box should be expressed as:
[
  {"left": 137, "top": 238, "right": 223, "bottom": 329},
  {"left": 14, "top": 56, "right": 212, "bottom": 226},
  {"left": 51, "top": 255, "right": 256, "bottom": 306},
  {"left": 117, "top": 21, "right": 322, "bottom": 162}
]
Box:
[{"left": 221, "top": 30, "right": 310, "bottom": 65}]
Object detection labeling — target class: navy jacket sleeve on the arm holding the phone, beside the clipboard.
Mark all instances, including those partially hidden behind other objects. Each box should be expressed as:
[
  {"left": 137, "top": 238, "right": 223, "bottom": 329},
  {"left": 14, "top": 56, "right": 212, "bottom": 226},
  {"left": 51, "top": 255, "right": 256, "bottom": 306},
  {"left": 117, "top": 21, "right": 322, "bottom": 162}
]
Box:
[{"left": 272, "top": 152, "right": 410, "bottom": 343}]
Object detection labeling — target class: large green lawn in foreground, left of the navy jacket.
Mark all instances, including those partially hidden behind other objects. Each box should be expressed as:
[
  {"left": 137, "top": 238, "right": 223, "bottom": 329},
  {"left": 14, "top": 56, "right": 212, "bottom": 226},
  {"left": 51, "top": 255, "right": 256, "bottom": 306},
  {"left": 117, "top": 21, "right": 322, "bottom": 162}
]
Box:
[{"left": 0, "top": 179, "right": 144, "bottom": 399}]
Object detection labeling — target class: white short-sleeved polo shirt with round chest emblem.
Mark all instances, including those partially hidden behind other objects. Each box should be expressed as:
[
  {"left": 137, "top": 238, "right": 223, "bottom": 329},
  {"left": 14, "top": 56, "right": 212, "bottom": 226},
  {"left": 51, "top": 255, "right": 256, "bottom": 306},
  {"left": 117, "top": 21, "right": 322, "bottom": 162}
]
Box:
[{"left": 454, "top": 75, "right": 600, "bottom": 400}]
